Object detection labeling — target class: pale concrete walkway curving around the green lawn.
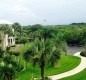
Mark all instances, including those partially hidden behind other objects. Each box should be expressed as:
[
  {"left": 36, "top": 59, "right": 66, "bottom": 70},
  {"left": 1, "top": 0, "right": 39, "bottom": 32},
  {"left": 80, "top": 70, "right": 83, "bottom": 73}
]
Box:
[{"left": 49, "top": 52, "right": 86, "bottom": 80}]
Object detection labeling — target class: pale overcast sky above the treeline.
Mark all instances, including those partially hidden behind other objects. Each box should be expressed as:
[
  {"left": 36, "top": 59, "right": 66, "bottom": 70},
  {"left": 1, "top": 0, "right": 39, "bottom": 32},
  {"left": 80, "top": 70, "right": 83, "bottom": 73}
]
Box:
[{"left": 0, "top": 0, "right": 86, "bottom": 25}]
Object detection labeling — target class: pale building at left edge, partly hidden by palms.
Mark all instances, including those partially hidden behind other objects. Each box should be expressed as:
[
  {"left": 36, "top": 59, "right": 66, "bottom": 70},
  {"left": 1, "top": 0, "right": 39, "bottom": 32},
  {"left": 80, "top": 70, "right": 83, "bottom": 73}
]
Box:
[{"left": 0, "top": 20, "right": 15, "bottom": 50}]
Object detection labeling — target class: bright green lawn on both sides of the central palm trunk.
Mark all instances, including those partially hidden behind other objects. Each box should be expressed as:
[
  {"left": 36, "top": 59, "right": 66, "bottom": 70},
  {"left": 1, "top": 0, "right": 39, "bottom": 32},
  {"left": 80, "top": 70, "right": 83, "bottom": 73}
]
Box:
[{"left": 18, "top": 55, "right": 80, "bottom": 80}]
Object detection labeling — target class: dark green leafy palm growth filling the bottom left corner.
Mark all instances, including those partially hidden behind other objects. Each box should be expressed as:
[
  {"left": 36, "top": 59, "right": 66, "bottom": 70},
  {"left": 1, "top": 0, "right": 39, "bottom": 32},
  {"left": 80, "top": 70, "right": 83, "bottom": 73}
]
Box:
[{"left": 0, "top": 47, "right": 18, "bottom": 80}]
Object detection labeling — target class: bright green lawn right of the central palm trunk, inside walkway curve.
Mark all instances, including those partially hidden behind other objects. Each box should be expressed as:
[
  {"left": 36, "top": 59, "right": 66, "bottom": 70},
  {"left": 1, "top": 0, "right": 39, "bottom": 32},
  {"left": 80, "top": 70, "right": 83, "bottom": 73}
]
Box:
[{"left": 46, "top": 55, "right": 81, "bottom": 75}]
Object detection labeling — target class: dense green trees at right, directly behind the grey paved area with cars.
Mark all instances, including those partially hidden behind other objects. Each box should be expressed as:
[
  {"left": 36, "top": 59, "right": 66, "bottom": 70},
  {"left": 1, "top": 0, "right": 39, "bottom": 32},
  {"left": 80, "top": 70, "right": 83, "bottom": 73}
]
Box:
[{"left": 59, "top": 25, "right": 86, "bottom": 46}]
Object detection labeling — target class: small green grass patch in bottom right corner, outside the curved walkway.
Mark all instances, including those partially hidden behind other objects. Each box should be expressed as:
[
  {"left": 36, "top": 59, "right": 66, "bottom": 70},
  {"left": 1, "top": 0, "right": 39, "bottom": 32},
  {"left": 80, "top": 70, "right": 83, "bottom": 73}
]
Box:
[{"left": 60, "top": 69, "right": 86, "bottom": 80}]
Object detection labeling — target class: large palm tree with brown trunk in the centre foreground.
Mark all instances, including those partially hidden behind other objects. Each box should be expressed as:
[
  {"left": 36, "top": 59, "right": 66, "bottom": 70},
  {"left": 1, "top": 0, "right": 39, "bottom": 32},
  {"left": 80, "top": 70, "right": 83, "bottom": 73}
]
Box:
[{"left": 24, "top": 38, "right": 60, "bottom": 80}]
